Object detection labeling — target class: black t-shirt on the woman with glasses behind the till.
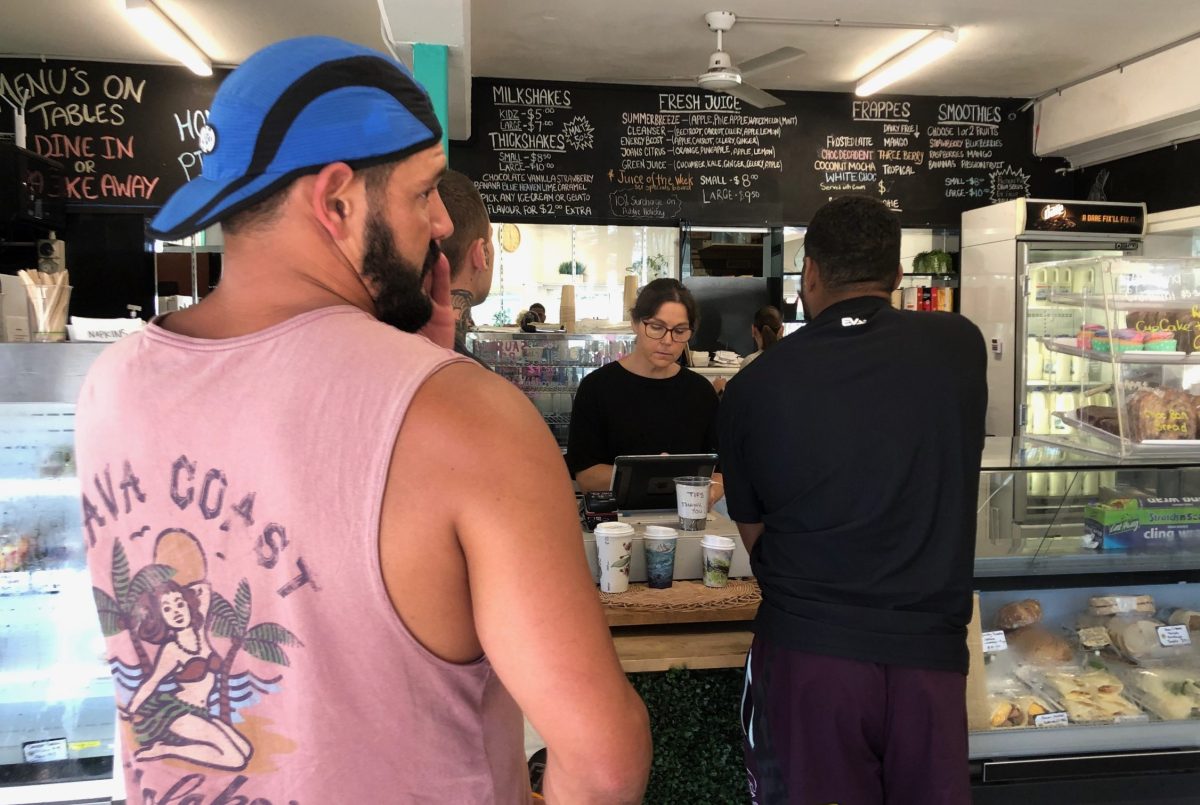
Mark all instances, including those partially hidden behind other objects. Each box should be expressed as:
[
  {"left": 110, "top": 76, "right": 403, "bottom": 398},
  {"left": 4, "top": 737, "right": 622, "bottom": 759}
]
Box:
[{"left": 566, "top": 361, "right": 716, "bottom": 476}]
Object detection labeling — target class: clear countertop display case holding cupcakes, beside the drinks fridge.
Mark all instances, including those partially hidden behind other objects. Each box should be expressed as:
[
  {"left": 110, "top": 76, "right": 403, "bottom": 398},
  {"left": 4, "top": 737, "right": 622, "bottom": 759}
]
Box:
[{"left": 1022, "top": 257, "right": 1200, "bottom": 458}]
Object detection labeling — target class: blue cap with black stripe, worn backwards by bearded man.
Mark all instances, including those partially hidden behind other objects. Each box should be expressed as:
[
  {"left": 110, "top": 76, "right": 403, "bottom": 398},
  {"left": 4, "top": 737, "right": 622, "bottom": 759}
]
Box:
[{"left": 149, "top": 36, "right": 442, "bottom": 240}]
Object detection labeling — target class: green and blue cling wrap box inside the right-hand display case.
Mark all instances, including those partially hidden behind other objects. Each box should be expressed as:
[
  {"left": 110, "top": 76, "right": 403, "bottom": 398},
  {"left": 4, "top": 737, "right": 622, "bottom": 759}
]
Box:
[{"left": 1084, "top": 497, "right": 1200, "bottom": 551}]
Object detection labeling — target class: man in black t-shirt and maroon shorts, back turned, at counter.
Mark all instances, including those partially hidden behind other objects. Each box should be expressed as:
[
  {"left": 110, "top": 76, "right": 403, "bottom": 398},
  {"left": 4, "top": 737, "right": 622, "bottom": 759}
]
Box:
[{"left": 719, "top": 197, "right": 988, "bottom": 805}]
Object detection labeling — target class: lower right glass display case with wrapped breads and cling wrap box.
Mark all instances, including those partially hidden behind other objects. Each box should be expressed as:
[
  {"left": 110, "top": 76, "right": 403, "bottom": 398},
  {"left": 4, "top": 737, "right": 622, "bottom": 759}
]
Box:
[{"left": 968, "top": 438, "right": 1200, "bottom": 782}]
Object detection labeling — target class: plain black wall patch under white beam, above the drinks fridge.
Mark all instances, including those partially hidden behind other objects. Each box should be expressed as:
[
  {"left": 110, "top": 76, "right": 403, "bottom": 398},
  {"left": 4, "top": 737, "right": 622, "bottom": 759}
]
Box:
[{"left": 1073, "top": 140, "right": 1200, "bottom": 212}]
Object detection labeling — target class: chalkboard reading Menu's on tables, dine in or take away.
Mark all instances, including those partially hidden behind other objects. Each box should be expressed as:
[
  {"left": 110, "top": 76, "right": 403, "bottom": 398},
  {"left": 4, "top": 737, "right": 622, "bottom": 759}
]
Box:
[{"left": 0, "top": 59, "right": 228, "bottom": 208}]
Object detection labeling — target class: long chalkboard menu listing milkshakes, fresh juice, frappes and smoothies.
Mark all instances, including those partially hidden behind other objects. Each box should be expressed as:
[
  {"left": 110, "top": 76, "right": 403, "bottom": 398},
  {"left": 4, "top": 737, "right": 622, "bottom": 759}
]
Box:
[{"left": 450, "top": 78, "right": 1070, "bottom": 227}]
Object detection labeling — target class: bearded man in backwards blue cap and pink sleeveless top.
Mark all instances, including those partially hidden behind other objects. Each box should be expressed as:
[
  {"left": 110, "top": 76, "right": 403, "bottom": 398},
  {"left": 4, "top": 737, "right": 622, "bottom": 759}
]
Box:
[{"left": 77, "top": 37, "right": 650, "bottom": 804}]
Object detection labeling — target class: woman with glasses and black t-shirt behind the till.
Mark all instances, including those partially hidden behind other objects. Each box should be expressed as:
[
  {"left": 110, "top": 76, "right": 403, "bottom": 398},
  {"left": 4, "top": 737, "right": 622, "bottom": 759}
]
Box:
[{"left": 566, "top": 278, "right": 725, "bottom": 501}]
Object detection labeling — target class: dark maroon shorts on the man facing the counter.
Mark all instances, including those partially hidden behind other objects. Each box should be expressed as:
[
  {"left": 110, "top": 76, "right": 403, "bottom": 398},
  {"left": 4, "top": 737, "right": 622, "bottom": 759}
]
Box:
[{"left": 742, "top": 637, "right": 971, "bottom": 805}]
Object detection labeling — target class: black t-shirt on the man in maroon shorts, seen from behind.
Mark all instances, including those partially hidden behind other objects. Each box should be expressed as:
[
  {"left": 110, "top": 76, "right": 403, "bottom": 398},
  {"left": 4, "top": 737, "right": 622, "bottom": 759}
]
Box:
[{"left": 719, "top": 296, "right": 988, "bottom": 673}]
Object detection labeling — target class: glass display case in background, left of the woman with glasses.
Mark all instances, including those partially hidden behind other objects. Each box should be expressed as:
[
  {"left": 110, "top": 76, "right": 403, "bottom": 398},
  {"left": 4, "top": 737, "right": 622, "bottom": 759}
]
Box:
[{"left": 467, "top": 325, "right": 635, "bottom": 447}]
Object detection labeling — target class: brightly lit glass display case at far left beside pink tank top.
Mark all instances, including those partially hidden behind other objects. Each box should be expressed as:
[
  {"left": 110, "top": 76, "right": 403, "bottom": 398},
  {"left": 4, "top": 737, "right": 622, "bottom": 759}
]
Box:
[{"left": 0, "top": 344, "right": 115, "bottom": 803}]
